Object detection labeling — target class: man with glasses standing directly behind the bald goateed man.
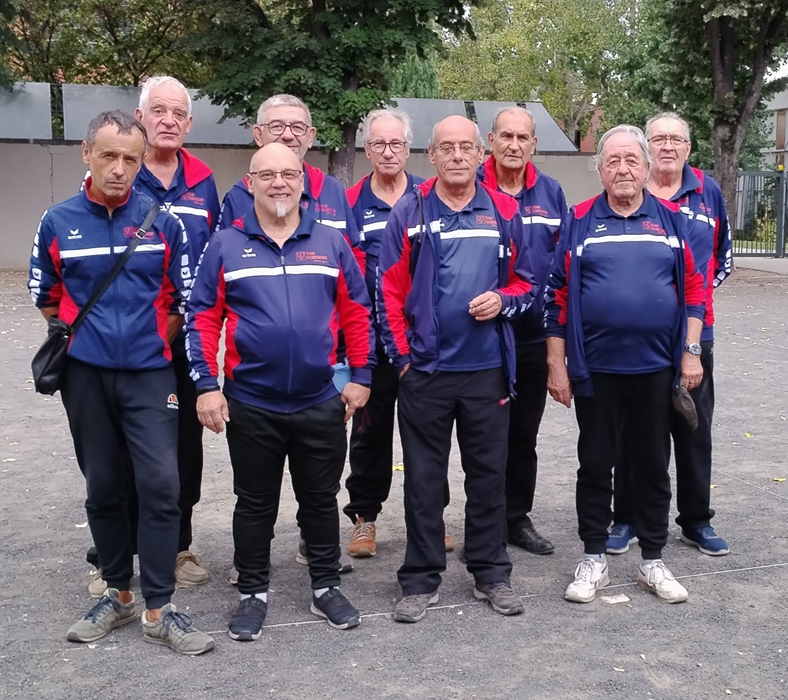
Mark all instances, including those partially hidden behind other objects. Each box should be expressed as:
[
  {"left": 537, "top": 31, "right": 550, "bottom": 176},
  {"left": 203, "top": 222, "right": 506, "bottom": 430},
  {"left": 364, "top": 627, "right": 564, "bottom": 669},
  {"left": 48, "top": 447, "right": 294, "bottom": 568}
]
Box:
[{"left": 217, "top": 95, "right": 364, "bottom": 270}]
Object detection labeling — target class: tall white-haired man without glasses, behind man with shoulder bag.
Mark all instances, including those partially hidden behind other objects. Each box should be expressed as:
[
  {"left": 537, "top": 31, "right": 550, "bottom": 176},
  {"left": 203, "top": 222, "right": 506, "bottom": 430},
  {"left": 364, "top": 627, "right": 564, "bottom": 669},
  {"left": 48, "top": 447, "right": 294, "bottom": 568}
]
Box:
[{"left": 134, "top": 76, "right": 219, "bottom": 585}]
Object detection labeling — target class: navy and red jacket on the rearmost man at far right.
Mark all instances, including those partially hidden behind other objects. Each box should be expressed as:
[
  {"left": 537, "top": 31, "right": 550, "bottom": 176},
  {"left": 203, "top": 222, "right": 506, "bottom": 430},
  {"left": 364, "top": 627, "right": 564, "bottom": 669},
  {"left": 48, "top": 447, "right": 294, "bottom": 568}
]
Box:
[{"left": 671, "top": 163, "right": 733, "bottom": 341}]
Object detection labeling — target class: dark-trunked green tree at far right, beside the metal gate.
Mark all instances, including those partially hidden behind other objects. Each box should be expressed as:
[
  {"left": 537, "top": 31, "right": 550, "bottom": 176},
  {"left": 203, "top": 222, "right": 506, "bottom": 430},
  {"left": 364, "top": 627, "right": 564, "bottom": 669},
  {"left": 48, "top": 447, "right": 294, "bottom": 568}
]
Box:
[{"left": 602, "top": 0, "right": 788, "bottom": 216}]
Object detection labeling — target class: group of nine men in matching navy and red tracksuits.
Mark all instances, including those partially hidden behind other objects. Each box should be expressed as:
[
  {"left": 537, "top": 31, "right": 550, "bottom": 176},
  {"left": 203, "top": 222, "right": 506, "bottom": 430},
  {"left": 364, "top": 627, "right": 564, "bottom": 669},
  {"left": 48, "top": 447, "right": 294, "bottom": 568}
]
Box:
[{"left": 29, "top": 76, "right": 730, "bottom": 655}]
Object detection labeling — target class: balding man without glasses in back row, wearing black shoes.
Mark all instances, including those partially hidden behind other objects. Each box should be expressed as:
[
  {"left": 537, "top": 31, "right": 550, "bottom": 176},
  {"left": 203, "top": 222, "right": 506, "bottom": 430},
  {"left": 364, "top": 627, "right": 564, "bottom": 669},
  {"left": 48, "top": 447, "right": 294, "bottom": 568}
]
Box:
[{"left": 477, "top": 107, "right": 566, "bottom": 554}]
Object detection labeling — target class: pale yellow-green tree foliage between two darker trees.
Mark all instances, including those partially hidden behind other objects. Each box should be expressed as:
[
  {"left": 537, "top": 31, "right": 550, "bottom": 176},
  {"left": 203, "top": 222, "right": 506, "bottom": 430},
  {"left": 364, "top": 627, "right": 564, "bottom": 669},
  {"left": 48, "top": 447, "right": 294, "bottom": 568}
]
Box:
[{"left": 438, "top": 0, "right": 630, "bottom": 139}]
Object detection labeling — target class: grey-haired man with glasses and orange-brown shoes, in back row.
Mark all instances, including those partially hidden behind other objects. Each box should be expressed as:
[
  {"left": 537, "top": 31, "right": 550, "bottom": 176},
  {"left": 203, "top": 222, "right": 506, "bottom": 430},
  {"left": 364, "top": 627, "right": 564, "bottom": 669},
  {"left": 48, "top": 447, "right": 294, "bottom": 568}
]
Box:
[{"left": 344, "top": 107, "right": 438, "bottom": 557}]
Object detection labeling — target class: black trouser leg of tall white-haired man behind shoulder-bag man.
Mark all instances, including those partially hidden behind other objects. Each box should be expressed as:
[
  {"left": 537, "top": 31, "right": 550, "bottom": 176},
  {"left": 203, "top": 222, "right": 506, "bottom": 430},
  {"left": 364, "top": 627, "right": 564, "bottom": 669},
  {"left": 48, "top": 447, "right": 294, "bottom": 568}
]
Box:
[{"left": 172, "top": 354, "right": 203, "bottom": 552}]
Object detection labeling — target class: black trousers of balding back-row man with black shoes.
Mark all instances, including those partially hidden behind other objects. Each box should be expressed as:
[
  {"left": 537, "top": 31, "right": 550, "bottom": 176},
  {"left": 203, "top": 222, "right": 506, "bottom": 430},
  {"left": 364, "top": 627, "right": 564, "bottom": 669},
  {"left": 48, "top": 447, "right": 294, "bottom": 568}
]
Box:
[{"left": 506, "top": 342, "right": 547, "bottom": 532}]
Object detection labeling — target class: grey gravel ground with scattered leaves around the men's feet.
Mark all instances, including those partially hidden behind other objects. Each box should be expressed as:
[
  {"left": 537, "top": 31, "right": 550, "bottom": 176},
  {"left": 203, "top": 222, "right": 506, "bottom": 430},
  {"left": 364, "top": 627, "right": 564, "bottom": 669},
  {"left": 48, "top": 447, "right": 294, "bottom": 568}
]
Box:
[{"left": 0, "top": 270, "right": 788, "bottom": 700}]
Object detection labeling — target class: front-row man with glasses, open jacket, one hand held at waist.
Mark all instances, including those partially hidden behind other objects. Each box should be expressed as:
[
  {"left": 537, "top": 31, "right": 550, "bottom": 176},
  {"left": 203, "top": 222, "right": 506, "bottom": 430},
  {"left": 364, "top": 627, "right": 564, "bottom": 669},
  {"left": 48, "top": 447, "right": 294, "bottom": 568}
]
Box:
[{"left": 377, "top": 116, "right": 535, "bottom": 622}]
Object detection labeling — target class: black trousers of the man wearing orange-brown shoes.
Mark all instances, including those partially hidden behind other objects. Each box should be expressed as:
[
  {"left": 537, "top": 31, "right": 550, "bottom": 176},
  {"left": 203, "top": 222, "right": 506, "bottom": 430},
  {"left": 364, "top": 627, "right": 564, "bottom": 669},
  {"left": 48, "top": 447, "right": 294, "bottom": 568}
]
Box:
[{"left": 343, "top": 352, "right": 449, "bottom": 523}]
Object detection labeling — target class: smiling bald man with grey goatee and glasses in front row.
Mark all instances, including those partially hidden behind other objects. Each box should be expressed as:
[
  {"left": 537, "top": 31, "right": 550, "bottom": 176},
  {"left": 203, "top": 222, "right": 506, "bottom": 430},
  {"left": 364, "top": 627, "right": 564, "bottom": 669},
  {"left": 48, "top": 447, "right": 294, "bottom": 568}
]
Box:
[{"left": 187, "top": 143, "right": 375, "bottom": 641}]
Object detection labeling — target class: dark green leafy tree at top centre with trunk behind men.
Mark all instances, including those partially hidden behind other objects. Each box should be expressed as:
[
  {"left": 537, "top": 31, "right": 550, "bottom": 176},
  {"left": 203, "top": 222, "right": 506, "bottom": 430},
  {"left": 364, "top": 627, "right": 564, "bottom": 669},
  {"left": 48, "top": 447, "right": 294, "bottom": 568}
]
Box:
[{"left": 195, "top": 0, "right": 475, "bottom": 183}]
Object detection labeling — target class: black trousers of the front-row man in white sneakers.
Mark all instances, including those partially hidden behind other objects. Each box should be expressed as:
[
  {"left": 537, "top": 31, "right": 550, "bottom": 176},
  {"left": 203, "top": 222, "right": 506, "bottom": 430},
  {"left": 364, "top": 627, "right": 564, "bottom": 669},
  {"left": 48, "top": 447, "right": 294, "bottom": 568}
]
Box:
[{"left": 575, "top": 368, "right": 674, "bottom": 559}]
